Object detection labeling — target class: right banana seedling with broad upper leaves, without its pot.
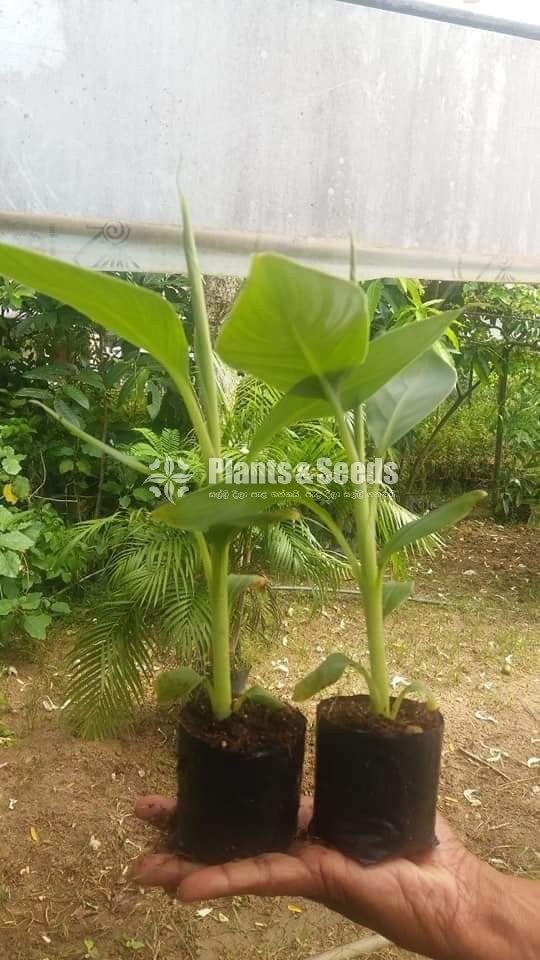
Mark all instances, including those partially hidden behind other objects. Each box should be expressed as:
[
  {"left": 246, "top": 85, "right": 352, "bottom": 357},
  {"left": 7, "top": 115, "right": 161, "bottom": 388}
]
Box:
[{"left": 216, "top": 254, "right": 485, "bottom": 717}]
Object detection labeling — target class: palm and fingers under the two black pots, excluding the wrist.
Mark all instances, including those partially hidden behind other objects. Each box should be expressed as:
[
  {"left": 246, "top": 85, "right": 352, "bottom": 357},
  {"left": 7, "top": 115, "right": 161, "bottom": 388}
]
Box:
[{"left": 135, "top": 797, "right": 478, "bottom": 957}]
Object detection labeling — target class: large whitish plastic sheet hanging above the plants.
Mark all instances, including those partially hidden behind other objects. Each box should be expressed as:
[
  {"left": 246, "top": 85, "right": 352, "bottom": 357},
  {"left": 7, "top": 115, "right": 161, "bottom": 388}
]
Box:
[{"left": 0, "top": 0, "right": 540, "bottom": 281}]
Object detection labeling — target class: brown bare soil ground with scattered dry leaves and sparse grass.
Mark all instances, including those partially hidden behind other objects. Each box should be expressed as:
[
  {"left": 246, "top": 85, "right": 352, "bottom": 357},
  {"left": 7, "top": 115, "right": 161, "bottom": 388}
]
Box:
[{"left": 0, "top": 521, "right": 540, "bottom": 960}]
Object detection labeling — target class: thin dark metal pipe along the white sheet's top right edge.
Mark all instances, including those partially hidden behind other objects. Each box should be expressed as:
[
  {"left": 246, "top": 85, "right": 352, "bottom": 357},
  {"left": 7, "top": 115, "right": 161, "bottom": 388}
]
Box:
[{"left": 340, "top": 0, "right": 540, "bottom": 40}]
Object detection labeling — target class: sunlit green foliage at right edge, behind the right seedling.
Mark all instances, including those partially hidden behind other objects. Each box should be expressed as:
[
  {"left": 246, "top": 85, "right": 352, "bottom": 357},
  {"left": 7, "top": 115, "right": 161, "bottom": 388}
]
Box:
[{"left": 366, "top": 280, "right": 540, "bottom": 523}]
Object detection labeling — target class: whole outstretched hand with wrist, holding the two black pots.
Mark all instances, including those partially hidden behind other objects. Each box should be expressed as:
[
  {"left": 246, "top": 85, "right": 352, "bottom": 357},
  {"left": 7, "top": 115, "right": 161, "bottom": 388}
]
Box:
[{"left": 133, "top": 796, "right": 540, "bottom": 960}]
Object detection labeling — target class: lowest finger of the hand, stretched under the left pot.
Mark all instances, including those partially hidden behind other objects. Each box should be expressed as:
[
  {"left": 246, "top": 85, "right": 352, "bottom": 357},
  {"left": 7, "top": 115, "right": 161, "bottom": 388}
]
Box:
[{"left": 178, "top": 853, "right": 317, "bottom": 903}]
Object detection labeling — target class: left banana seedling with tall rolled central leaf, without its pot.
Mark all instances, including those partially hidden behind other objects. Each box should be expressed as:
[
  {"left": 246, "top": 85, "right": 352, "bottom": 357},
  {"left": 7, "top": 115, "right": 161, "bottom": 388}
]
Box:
[{"left": 0, "top": 210, "right": 299, "bottom": 721}]
